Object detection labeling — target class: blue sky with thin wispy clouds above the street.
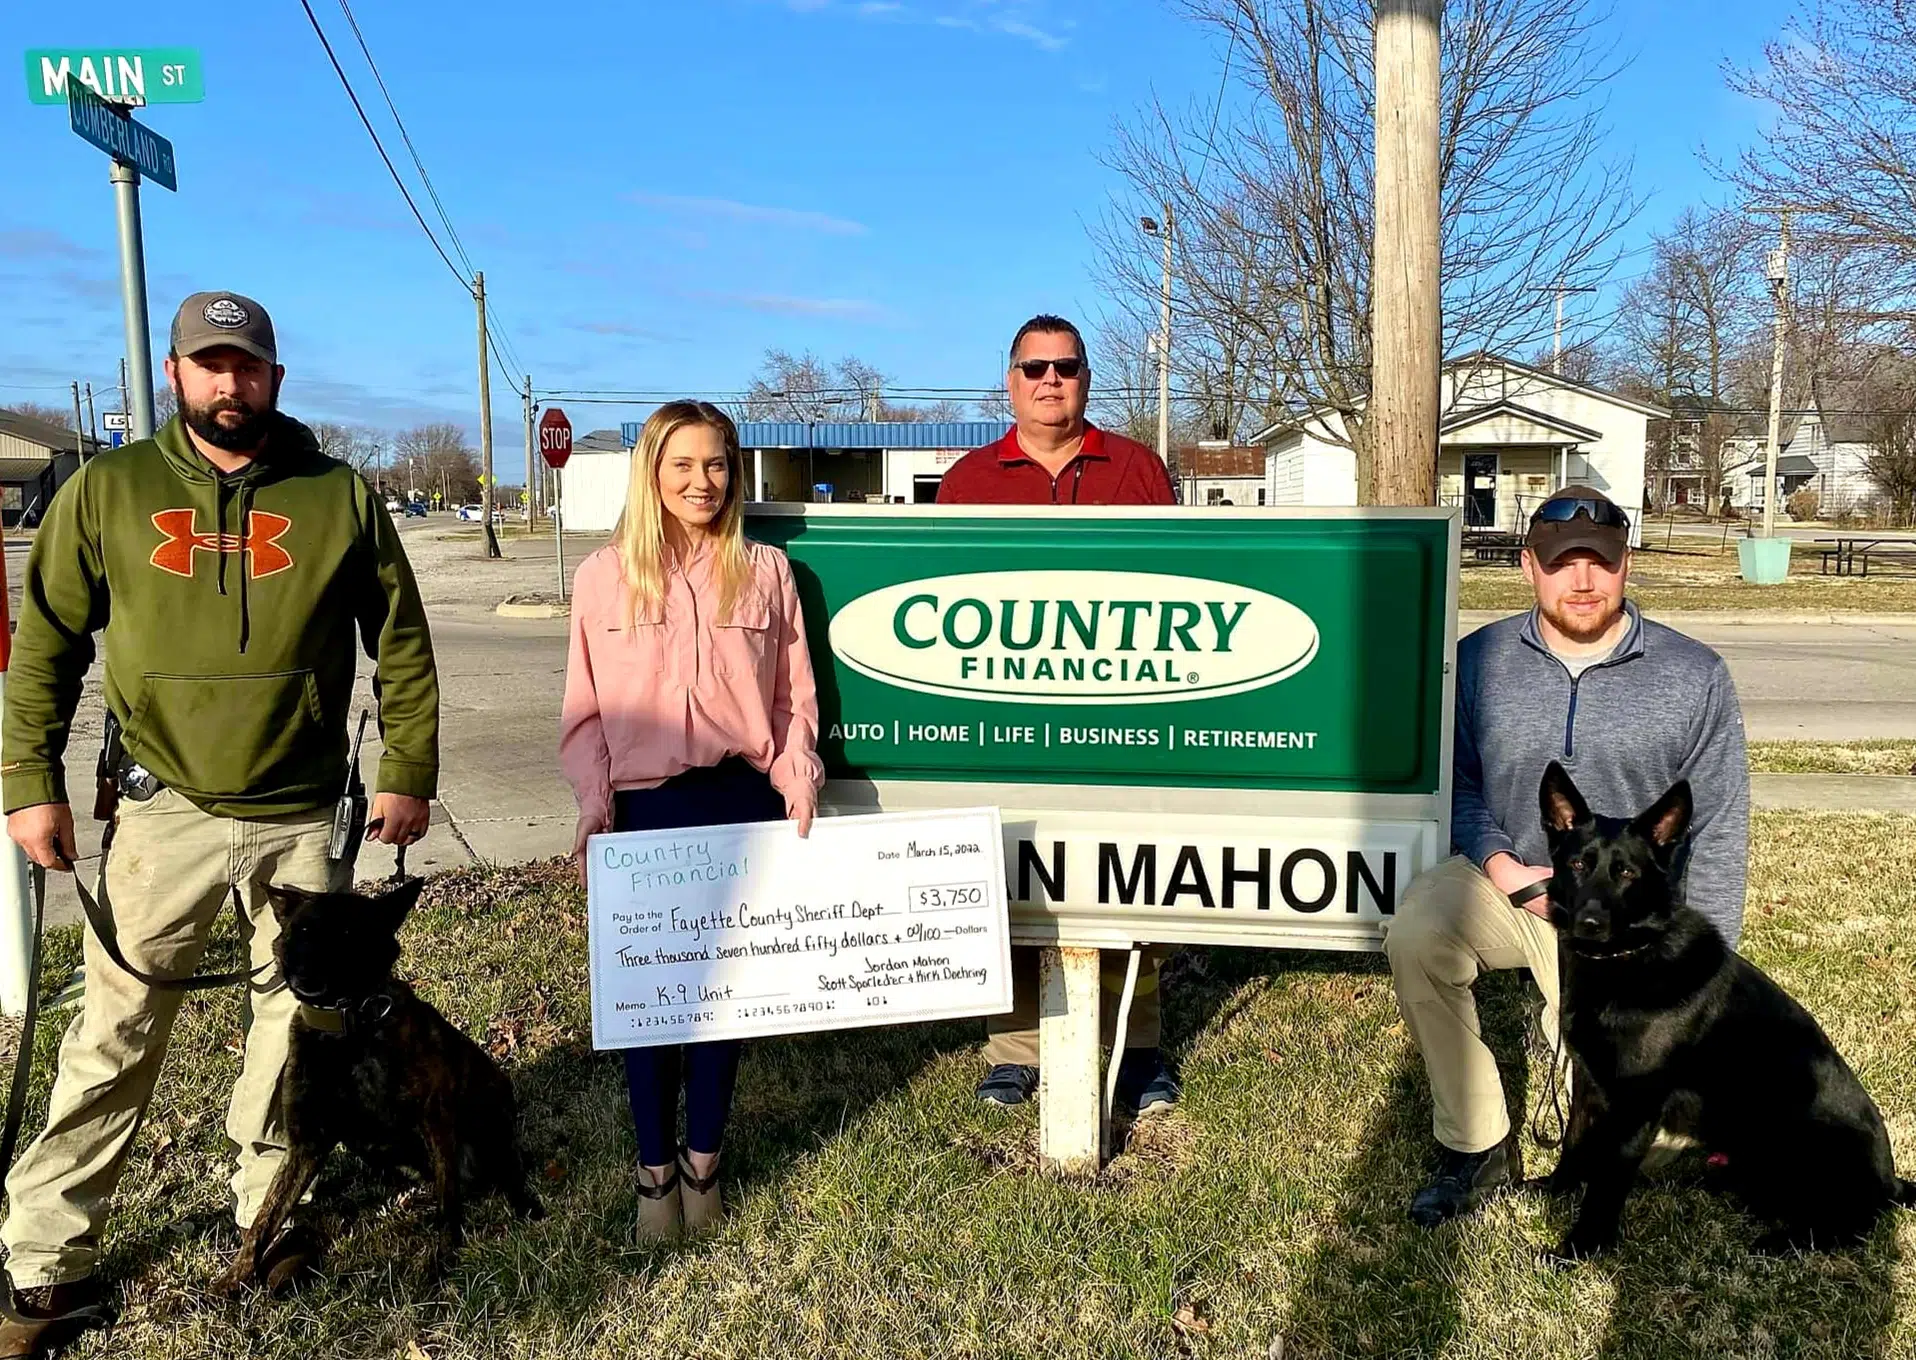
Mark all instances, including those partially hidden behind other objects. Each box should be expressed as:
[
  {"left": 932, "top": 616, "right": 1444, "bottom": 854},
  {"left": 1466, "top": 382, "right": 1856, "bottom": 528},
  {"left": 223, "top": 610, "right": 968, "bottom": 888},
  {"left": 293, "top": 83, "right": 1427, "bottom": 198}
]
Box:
[{"left": 0, "top": 0, "right": 1790, "bottom": 448}]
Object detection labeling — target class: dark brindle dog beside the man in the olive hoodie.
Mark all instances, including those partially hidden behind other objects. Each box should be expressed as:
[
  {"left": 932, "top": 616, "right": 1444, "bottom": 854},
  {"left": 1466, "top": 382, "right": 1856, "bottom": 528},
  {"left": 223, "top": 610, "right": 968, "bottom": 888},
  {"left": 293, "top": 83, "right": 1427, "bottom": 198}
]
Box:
[{"left": 213, "top": 879, "right": 544, "bottom": 1293}]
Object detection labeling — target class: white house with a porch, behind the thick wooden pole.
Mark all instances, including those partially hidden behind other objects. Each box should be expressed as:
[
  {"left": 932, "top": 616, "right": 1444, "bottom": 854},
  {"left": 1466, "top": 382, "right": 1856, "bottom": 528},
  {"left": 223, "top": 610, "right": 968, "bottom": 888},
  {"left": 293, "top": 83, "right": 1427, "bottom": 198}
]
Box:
[{"left": 1253, "top": 354, "right": 1669, "bottom": 533}]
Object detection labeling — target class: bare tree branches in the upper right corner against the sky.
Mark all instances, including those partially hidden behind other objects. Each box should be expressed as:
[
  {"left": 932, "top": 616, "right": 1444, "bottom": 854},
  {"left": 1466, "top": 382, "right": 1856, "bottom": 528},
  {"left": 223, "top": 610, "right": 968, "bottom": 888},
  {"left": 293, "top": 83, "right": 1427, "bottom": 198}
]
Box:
[{"left": 1726, "top": 0, "right": 1916, "bottom": 329}]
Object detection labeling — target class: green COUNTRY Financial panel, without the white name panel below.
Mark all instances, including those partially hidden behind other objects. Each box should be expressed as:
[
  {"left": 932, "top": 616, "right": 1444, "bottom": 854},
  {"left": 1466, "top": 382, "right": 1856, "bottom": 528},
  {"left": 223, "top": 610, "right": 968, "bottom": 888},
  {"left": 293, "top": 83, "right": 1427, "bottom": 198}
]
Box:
[{"left": 753, "top": 510, "right": 1454, "bottom": 795}]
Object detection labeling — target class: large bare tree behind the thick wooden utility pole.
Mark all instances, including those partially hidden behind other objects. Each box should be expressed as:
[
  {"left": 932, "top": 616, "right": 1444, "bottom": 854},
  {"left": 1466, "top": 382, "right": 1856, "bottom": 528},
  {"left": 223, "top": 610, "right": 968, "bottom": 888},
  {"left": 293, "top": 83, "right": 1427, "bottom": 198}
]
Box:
[{"left": 1094, "top": 0, "right": 1636, "bottom": 485}]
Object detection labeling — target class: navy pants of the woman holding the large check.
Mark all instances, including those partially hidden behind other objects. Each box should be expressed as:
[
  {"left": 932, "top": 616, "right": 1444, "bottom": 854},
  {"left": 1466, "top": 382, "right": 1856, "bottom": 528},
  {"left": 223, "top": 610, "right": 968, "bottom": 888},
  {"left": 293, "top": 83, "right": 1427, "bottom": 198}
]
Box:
[{"left": 611, "top": 757, "right": 786, "bottom": 1167}]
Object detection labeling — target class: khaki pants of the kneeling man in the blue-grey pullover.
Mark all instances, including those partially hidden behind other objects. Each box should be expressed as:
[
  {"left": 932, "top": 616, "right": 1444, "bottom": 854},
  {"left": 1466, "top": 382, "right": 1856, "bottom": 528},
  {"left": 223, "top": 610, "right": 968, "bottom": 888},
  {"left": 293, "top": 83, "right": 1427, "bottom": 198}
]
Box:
[{"left": 1383, "top": 856, "right": 1558, "bottom": 1153}]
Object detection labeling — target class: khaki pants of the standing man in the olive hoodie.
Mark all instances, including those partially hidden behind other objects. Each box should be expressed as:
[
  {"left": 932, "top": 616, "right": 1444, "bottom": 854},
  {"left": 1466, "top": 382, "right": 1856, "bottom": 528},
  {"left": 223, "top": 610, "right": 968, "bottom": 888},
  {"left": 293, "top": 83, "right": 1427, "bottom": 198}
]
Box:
[{"left": 0, "top": 789, "right": 343, "bottom": 1289}]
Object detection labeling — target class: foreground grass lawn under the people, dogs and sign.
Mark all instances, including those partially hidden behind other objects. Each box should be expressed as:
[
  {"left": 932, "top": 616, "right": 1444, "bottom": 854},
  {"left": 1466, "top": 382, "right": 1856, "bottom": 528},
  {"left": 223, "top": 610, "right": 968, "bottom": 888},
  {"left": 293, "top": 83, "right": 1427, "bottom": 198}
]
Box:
[{"left": 14, "top": 812, "right": 1916, "bottom": 1360}]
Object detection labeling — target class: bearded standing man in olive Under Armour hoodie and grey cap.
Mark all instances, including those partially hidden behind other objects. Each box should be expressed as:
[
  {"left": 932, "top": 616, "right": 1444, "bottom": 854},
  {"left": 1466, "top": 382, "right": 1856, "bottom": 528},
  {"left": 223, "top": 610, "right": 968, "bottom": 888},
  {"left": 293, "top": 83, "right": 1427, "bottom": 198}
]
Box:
[{"left": 0, "top": 293, "right": 439, "bottom": 1356}]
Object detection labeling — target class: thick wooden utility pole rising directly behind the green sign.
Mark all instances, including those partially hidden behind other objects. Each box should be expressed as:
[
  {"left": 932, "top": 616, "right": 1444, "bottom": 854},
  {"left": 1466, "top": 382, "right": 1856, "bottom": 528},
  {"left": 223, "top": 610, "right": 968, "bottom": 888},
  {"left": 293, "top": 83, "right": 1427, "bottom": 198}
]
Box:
[{"left": 1357, "top": 0, "right": 1443, "bottom": 506}]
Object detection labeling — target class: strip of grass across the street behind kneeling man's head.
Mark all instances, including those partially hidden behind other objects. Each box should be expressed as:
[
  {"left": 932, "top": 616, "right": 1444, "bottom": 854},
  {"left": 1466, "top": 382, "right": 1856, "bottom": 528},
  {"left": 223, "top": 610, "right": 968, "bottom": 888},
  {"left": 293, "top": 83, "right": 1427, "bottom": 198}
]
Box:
[{"left": 1458, "top": 544, "right": 1916, "bottom": 613}]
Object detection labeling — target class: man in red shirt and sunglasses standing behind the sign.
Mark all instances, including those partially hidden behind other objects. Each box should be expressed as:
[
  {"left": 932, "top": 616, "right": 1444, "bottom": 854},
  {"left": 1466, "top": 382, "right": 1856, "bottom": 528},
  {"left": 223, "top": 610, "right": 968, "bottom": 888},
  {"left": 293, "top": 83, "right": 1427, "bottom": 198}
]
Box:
[{"left": 939, "top": 316, "right": 1178, "bottom": 1115}]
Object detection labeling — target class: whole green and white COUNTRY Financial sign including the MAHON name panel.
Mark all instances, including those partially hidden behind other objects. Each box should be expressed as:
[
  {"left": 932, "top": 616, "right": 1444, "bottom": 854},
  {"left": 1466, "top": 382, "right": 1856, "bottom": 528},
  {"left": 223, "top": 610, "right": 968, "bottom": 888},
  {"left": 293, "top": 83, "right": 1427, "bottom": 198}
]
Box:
[{"left": 751, "top": 506, "right": 1458, "bottom": 948}]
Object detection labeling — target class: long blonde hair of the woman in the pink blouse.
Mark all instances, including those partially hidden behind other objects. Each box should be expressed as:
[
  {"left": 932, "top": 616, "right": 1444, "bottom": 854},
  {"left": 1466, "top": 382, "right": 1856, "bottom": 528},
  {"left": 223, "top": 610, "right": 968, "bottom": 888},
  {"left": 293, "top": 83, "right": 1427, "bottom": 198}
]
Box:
[{"left": 611, "top": 400, "right": 751, "bottom": 621}]
